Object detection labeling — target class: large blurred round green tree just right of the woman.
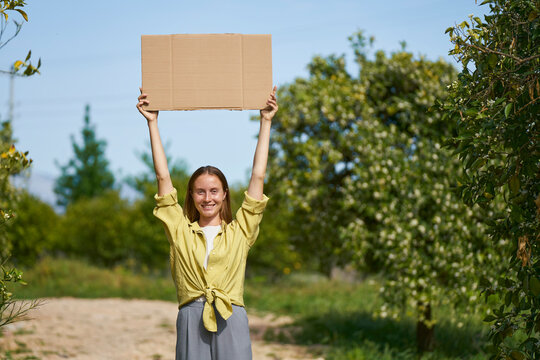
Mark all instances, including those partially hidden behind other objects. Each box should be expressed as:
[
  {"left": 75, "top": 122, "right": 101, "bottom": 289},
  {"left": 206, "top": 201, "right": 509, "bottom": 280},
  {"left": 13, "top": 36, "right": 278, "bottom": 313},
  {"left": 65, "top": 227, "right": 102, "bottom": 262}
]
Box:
[{"left": 269, "top": 34, "right": 504, "bottom": 351}]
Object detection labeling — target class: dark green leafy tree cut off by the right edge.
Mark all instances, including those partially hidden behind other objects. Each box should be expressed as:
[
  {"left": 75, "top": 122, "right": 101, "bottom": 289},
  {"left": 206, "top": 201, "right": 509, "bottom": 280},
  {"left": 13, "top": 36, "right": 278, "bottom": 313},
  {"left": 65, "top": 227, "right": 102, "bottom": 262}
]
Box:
[{"left": 442, "top": 0, "right": 540, "bottom": 359}]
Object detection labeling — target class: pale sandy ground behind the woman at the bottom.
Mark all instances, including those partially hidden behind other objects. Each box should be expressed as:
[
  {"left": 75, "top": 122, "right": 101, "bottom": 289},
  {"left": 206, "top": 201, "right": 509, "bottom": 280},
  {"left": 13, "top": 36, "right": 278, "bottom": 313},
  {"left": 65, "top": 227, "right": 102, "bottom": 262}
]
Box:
[{"left": 0, "top": 298, "right": 322, "bottom": 360}]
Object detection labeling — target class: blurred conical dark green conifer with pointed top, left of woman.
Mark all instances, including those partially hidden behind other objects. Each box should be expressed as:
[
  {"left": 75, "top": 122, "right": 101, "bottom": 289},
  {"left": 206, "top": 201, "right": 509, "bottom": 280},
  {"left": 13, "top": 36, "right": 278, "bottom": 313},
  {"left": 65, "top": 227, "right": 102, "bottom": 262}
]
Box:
[{"left": 54, "top": 105, "right": 114, "bottom": 207}]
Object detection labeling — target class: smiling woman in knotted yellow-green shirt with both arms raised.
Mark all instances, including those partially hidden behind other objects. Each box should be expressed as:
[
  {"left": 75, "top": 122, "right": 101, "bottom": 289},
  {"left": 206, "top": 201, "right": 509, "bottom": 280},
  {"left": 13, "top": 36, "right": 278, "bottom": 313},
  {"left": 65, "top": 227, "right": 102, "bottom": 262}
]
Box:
[{"left": 137, "top": 87, "right": 278, "bottom": 360}]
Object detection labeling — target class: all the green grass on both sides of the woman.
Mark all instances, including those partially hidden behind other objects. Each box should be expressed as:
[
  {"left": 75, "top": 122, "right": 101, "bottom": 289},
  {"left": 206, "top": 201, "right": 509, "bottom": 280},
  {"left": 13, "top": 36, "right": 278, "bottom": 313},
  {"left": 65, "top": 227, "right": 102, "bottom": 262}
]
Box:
[{"left": 6, "top": 258, "right": 488, "bottom": 360}]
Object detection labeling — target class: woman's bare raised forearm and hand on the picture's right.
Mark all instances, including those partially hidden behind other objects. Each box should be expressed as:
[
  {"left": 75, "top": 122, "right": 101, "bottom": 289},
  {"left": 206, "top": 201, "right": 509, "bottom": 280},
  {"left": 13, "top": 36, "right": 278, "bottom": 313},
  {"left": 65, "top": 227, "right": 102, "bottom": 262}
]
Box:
[{"left": 247, "top": 86, "right": 278, "bottom": 200}]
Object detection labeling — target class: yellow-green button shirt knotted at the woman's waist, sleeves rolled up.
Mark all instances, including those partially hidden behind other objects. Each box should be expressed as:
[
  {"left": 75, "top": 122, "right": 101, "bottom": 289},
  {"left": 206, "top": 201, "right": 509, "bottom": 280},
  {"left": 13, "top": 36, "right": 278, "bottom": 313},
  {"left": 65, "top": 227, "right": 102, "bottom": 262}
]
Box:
[{"left": 154, "top": 189, "right": 268, "bottom": 332}]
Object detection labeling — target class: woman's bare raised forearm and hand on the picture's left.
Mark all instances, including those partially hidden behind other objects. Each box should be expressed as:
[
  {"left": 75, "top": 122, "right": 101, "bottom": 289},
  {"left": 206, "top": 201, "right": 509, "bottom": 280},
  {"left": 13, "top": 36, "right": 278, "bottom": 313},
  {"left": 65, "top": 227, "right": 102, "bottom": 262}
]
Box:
[{"left": 137, "top": 89, "right": 173, "bottom": 196}]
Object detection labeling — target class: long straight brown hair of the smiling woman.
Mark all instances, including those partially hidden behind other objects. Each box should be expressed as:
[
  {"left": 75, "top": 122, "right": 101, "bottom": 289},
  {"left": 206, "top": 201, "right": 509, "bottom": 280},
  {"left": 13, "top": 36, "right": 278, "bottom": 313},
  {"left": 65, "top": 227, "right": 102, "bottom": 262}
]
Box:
[{"left": 184, "top": 165, "right": 232, "bottom": 224}]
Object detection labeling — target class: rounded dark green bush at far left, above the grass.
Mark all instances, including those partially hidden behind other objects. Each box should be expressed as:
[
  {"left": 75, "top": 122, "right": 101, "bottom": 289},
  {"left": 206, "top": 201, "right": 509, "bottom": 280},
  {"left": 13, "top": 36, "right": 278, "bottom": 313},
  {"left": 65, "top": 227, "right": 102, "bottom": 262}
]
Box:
[{"left": 6, "top": 191, "right": 59, "bottom": 266}]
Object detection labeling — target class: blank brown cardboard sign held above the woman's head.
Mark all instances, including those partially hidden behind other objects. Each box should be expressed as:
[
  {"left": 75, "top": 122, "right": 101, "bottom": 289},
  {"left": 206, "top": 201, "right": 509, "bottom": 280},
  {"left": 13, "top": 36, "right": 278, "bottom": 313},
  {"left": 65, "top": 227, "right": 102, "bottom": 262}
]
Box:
[{"left": 141, "top": 34, "right": 272, "bottom": 110}]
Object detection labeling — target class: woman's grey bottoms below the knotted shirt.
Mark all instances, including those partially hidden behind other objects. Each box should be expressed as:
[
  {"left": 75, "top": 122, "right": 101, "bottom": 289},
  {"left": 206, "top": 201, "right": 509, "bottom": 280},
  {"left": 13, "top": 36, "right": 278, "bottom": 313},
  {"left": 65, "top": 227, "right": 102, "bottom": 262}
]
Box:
[{"left": 176, "top": 301, "right": 252, "bottom": 360}]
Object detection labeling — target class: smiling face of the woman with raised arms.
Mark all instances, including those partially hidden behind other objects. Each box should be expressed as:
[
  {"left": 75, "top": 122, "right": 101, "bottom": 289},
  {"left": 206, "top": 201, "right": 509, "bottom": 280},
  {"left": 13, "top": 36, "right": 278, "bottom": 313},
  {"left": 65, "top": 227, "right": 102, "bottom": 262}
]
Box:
[{"left": 191, "top": 174, "right": 227, "bottom": 225}]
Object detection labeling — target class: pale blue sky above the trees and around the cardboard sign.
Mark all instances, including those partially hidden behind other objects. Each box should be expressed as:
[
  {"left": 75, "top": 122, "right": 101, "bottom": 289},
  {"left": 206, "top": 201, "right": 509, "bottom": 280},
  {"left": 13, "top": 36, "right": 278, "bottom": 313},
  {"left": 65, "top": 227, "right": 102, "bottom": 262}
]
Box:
[{"left": 0, "top": 0, "right": 488, "bottom": 202}]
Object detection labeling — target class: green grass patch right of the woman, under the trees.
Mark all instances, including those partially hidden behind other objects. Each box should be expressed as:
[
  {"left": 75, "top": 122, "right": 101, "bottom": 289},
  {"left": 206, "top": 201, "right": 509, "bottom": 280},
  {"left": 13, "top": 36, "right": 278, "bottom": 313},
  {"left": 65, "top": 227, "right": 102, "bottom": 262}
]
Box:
[{"left": 245, "top": 277, "right": 488, "bottom": 360}]
